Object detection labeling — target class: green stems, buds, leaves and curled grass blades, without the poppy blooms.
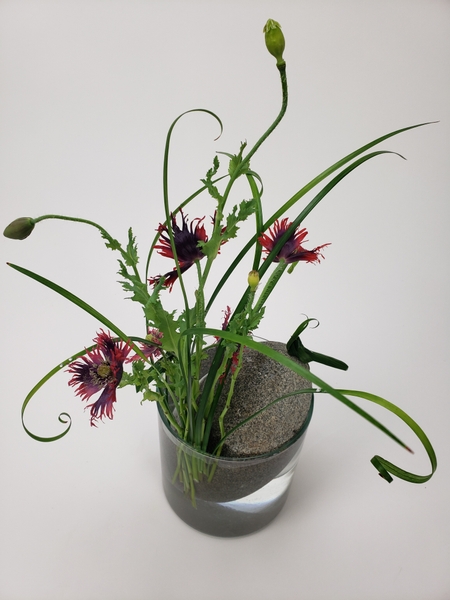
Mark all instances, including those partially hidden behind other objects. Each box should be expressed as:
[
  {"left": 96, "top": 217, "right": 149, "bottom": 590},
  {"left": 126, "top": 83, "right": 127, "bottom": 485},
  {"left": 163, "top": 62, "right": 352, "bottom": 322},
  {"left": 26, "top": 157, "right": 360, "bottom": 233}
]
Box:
[{"left": 5, "top": 20, "right": 437, "bottom": 497}]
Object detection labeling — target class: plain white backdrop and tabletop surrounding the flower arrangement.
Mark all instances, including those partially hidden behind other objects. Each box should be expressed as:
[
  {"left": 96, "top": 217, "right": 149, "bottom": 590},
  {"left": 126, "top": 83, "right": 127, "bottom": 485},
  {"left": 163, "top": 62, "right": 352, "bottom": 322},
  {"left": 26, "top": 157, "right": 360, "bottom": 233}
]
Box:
[{"left": 0, "top": 0, "right": 450, "bottom": 600}]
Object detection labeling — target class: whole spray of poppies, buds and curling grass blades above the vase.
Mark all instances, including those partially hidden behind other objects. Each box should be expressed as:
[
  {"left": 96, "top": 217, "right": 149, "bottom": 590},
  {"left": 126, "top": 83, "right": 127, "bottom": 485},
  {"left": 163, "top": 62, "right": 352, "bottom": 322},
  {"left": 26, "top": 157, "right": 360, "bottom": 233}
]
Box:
[{"left": 4, "top": 20, "right": 437, "bottom": 492}]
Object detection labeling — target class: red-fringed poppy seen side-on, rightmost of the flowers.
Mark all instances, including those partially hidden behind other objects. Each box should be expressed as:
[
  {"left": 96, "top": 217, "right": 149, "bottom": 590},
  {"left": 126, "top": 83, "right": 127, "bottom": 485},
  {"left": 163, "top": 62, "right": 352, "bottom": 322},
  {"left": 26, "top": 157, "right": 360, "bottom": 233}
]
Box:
[{"left": 258, "top": 218, "right": 330, "bottom": 263}]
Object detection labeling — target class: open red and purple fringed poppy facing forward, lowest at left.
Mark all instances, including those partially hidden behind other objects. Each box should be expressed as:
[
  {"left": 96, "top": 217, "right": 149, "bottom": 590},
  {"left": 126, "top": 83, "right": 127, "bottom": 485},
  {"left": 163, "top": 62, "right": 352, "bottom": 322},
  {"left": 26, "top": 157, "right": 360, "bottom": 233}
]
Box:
[{"left": 67, "top": 329, "right": 131, "bottom": 427}]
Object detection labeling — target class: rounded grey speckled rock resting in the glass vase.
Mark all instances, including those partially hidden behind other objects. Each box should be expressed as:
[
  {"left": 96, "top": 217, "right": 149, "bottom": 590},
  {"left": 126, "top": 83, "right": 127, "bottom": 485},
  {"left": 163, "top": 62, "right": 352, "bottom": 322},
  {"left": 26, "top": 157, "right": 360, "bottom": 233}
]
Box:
[{"left": 204, "top": 342, "right": 311, "bottom": 457}]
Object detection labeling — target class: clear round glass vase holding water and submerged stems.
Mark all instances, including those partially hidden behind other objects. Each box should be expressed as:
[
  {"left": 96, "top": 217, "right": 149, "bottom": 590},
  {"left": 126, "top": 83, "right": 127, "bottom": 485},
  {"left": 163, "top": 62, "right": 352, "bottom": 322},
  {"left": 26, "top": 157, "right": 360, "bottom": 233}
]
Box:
[{"left": 158, "top": 399, "right": 314, "bottom": 537}]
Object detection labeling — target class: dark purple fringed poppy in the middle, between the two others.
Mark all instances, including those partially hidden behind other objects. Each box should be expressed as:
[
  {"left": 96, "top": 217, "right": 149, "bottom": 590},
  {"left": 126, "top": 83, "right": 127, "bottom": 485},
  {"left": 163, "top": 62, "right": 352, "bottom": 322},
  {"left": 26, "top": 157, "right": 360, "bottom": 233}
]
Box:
[{"left": 149, "top": 210, "right": 208, "bottom": 290}]
